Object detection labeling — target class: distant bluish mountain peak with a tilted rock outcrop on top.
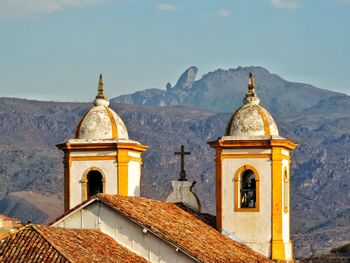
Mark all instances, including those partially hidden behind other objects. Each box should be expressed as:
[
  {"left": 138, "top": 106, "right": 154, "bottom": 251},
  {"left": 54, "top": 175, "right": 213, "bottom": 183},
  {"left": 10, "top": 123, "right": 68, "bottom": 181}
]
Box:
[{"left": 112, "top": 66, "right": 346, "bottom": 114}]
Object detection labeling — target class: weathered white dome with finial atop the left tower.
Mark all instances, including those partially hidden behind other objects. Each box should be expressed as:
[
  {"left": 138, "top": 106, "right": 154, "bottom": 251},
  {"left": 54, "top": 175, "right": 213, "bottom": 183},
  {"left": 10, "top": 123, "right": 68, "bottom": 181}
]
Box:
[{"left": 75, "top": 75, "right": 129, "bottom": 140}]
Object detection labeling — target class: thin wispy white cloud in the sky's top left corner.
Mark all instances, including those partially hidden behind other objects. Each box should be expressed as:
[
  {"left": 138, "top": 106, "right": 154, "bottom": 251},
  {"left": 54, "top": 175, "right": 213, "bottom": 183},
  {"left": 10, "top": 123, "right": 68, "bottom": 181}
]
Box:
[{"left": 0, "top": 0, "right": 100, "bottom": 20}]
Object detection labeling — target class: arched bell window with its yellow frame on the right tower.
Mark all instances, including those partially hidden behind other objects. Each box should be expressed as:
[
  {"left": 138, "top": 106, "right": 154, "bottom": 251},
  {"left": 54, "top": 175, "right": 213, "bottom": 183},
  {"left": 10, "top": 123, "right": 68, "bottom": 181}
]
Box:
[{"left": 234, "top": 165, "right": 260, "bottom": 212}]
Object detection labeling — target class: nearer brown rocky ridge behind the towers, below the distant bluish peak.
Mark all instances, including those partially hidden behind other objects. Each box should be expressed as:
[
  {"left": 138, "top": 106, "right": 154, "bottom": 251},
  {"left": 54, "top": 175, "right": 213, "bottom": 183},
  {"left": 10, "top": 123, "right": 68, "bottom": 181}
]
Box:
[{"left": 0, "top": 67, "right": 350, "bottom": 257}]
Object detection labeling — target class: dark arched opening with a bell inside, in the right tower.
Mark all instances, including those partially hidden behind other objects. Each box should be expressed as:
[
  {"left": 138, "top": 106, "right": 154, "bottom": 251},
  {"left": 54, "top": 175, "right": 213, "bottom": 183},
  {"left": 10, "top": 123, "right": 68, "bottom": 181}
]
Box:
[{"left": 241, "top": 170, "right": 256, "bottom": 208}]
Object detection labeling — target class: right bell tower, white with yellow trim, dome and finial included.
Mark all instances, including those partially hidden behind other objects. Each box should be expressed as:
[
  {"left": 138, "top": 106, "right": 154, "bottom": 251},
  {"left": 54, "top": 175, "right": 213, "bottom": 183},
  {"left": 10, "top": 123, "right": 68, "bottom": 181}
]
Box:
[{"left": 209, "top": 74, "right": 297, "bottom": 261}]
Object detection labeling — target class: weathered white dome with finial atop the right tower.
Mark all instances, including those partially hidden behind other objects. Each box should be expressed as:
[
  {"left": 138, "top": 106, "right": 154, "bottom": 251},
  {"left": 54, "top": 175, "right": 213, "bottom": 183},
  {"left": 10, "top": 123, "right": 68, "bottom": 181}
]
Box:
[{"left": 225, "top": 74, "right": 278, "bottom": 139}]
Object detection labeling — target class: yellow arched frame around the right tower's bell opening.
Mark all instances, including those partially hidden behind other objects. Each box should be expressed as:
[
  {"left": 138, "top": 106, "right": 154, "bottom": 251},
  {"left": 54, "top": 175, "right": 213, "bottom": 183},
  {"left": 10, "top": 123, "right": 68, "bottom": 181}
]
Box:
[{"left": 234, "top": 164, "right": 260, "bottom": 212}]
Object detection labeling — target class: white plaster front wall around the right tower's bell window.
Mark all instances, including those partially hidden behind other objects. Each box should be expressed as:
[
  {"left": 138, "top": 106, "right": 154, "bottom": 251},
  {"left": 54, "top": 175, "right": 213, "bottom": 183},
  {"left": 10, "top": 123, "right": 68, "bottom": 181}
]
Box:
[{"left": 222, "top": 158, "right": 272, "bottom": 256}]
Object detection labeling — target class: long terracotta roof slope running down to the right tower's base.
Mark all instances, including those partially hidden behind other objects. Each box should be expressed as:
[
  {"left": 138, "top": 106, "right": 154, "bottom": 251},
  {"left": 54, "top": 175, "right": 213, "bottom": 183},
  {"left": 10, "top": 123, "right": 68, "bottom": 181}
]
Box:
[{"left": 97, "top": 194, "right": 271, "bottom": 262}]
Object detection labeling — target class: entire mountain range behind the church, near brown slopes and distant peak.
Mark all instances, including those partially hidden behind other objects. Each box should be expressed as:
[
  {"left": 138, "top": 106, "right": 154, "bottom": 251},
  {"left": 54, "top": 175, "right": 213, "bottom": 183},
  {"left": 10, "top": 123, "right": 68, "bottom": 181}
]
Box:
[{"left": 0, "top": 67, "right": 350, "bottom": 257}]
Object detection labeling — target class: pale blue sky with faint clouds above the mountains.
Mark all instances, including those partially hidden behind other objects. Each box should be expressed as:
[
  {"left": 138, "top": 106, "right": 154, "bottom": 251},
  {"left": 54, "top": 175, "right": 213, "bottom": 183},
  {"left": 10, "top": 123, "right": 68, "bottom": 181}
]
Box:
[{"left": 0, "top": 0, "right": 350, "bottom": 101}]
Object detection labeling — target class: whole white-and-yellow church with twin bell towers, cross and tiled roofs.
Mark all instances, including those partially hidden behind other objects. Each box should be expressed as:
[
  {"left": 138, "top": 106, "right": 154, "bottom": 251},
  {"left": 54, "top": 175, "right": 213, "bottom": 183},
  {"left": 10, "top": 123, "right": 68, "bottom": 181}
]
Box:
[{"left": 0, "top": 72, "right": 297, "bottom": 262}]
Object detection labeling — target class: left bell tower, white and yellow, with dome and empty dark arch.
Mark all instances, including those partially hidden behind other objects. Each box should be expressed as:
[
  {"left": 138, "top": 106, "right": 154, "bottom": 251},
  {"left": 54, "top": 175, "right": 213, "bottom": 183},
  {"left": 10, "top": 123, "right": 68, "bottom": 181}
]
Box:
[{"left": 57, "top": 75, "right": 148, "bottom": 211}]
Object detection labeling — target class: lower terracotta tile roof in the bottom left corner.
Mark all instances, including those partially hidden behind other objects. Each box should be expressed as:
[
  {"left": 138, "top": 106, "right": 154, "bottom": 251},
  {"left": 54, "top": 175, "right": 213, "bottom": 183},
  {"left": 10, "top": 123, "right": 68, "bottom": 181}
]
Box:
[{"left": 0, "top": 225, "right": 147, "bottom": 263}]
